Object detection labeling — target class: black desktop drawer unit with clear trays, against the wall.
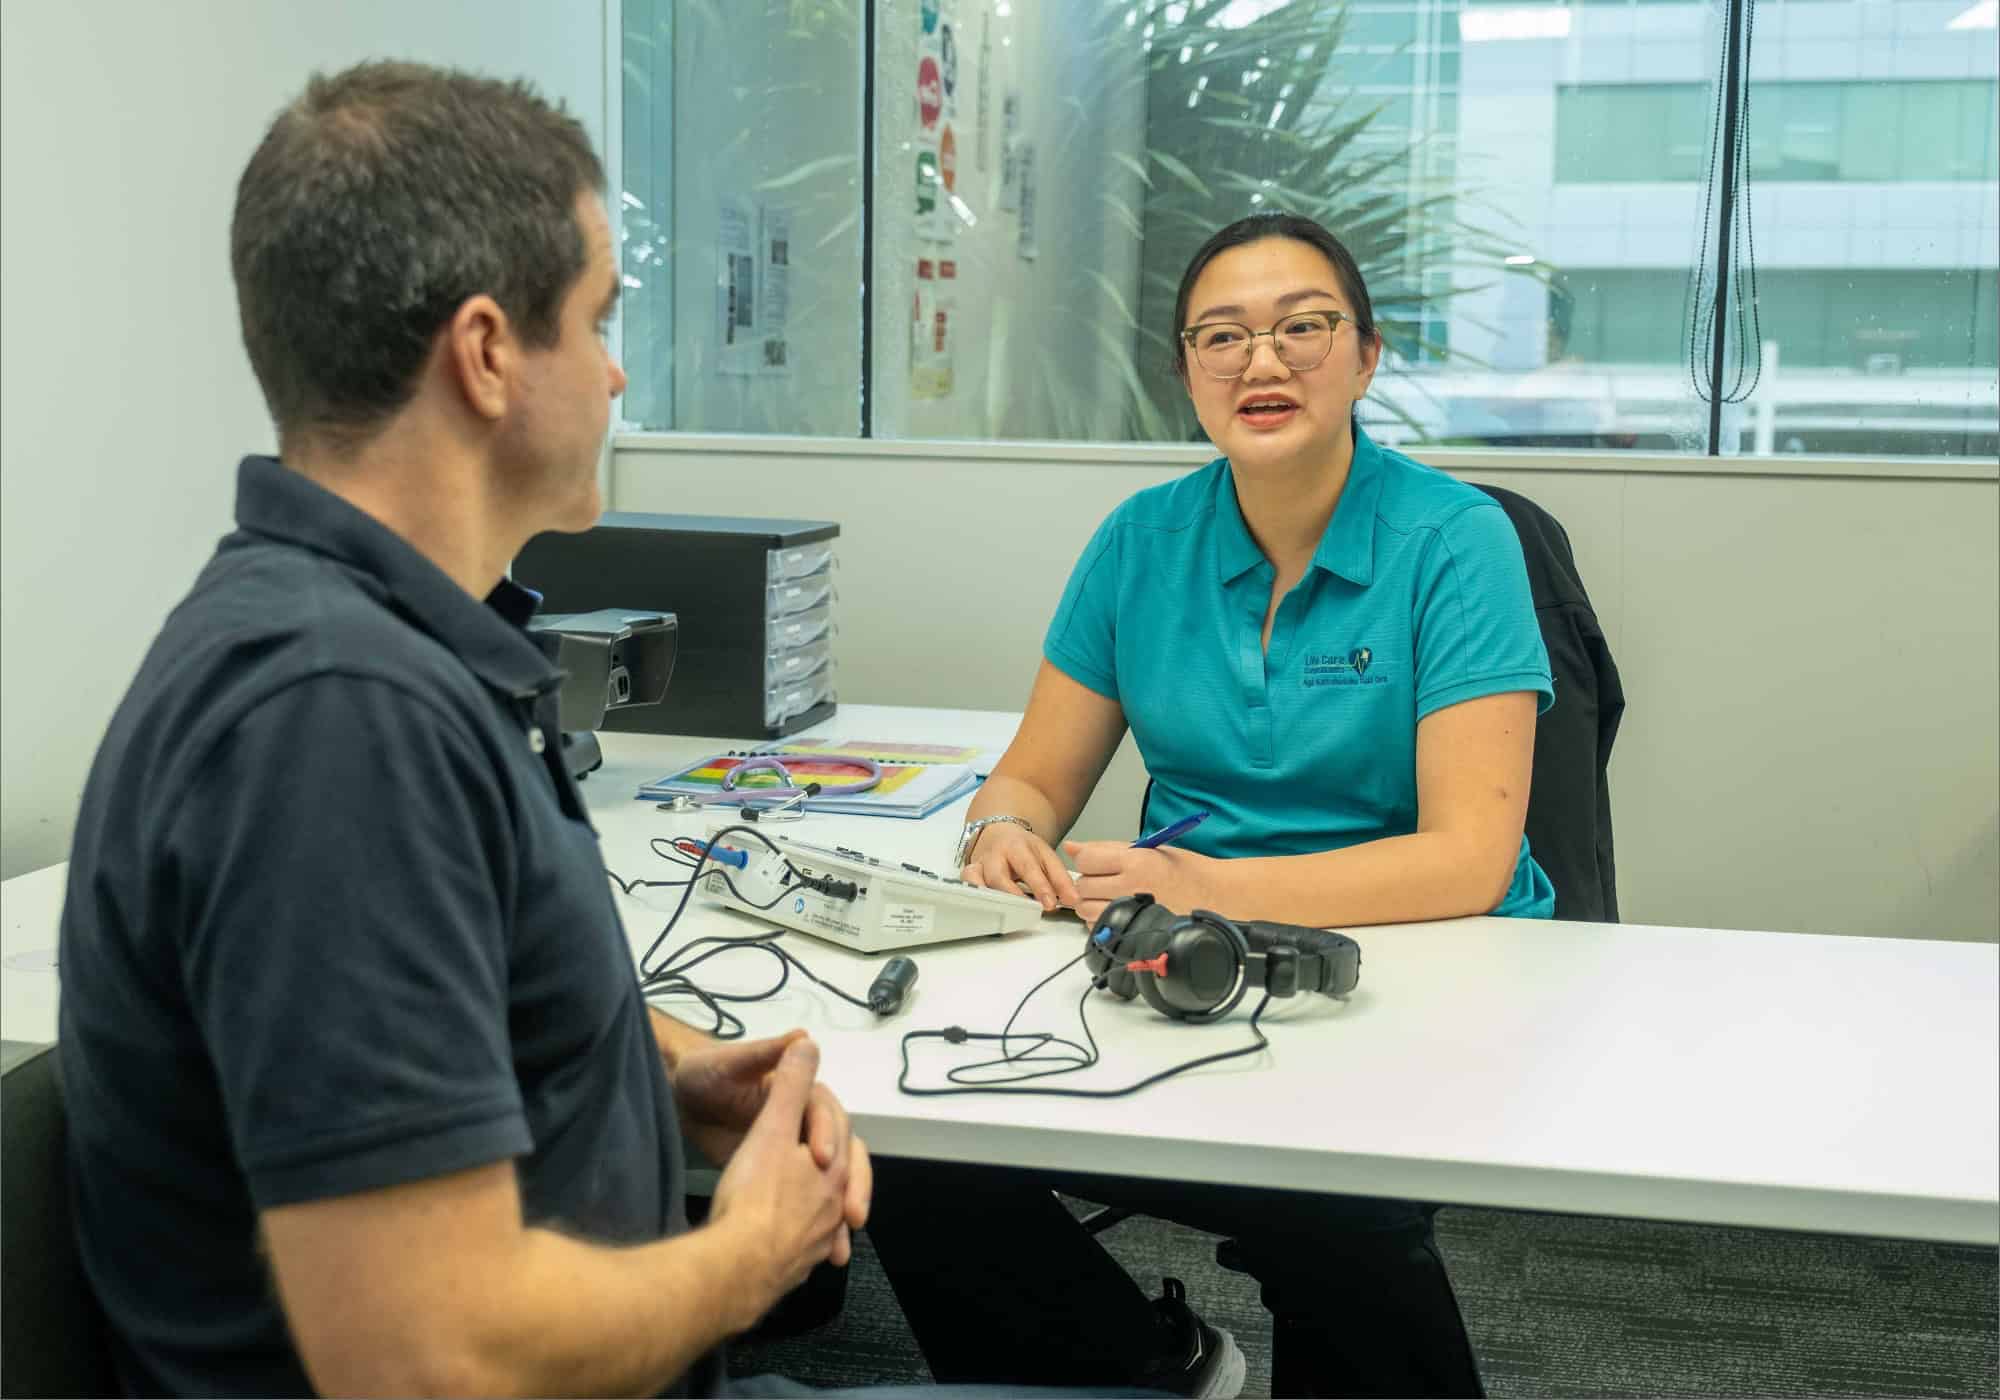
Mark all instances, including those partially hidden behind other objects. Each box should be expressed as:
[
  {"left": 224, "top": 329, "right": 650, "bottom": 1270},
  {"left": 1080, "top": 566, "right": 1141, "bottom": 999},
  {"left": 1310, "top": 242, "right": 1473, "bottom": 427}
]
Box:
[{"left": 514, "top": 512, "right": 840, "bottom": 738}]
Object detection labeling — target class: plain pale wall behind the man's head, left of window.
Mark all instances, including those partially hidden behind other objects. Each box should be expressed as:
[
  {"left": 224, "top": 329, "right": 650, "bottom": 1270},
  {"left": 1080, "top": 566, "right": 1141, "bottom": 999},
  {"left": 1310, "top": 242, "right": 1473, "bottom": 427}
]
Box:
[{"left": 0, "top": 0, "right": 606, "bottom": 876}]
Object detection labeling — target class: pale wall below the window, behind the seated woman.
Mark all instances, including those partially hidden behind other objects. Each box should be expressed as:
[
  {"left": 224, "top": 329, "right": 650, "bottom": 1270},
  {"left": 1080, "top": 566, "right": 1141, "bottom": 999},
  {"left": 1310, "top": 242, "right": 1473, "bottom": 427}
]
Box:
[{"left": 612, "top": 438, "right": 2000, "bottom": 940}]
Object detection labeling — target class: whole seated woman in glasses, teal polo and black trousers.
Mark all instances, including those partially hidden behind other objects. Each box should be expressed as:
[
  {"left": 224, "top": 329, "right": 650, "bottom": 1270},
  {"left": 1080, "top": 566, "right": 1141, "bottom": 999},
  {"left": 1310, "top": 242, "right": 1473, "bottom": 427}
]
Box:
[{"left": 870, "top": 214, "right": 1554, "bottom": 1396}]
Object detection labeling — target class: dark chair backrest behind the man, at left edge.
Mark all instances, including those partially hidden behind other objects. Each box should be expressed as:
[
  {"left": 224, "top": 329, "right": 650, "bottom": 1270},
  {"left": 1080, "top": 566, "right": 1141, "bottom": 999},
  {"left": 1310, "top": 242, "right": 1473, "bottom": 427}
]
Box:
[{"left": 0, "top": 1046, "right": 118, "bottom": 1396}]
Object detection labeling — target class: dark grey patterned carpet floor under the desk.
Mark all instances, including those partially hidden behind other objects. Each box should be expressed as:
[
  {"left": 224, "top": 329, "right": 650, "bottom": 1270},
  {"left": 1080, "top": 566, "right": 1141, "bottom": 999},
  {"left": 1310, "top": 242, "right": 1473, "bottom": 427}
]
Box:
[{"left": 730, "top": 1208, "right": 2000, "bottom": 1396}]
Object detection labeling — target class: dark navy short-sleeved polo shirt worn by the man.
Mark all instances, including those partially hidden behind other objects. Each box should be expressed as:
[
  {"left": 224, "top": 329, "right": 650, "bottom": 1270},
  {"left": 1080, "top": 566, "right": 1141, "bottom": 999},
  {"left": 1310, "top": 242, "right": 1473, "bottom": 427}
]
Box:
[{"left": 58, "top": 458, "right": 720, "bottom": 1396}]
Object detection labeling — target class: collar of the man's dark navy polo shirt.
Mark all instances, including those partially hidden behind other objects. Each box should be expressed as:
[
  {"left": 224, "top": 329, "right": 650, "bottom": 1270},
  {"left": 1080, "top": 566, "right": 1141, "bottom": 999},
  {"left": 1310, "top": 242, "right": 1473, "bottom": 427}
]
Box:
[{"left": 236, "top": 456, "right": 562, "bottom": 700}]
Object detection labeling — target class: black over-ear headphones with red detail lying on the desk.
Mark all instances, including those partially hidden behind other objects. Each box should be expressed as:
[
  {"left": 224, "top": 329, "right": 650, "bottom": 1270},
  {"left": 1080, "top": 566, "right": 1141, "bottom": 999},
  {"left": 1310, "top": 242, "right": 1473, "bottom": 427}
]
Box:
[{"left": 1084, "top": 894, "right": 1362, "bottom": 1020}]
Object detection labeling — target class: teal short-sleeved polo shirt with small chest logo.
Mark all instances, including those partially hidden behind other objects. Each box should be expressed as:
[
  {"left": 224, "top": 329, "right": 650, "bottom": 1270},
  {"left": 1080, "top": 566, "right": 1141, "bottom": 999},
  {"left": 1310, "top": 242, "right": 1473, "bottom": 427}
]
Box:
[{"left": 1042, "top": 432, "right": 1556, "bottom": 918}]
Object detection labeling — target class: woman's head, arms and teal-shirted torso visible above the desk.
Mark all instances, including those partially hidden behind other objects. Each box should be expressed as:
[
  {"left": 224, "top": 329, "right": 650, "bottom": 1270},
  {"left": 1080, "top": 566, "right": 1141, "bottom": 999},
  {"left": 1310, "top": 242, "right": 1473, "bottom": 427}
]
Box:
[{"left": 964, "top": 214, "right": 1554, "bottom": 926}]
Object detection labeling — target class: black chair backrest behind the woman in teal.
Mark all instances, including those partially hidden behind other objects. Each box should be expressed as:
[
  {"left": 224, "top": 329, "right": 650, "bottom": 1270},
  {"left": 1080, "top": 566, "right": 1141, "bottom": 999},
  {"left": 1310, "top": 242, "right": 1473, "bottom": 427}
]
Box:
[{"left": 1474, "top": 482, "right": 1624, "bottom": 924}]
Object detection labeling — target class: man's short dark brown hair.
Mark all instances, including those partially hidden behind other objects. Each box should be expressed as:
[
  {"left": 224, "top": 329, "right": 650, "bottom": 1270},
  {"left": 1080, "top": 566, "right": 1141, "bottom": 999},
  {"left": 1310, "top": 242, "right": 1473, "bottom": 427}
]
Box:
[{"left": 230, "top": 62, "right": 604, "bottom": 446}]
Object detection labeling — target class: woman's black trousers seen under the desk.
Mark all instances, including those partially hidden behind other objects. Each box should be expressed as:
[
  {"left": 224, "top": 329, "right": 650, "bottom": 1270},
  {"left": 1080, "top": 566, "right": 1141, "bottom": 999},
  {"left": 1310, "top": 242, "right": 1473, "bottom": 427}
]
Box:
[{"left": 868, "top": 1158, "right": 1484, "bottom": 1396}]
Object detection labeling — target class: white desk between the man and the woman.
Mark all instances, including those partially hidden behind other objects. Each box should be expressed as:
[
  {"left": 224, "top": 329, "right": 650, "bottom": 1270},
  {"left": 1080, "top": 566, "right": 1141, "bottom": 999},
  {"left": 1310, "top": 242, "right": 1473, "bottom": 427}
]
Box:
[{"left": 4, "top": 706, "right": 2000, "bottom": 1244}]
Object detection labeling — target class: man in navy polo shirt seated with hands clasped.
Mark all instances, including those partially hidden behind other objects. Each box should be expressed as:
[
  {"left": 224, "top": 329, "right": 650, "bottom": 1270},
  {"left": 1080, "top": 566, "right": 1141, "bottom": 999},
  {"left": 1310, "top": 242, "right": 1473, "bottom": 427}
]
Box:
[{"left": 60, "top": 64, "right": 870, "bottom": 1394}]
